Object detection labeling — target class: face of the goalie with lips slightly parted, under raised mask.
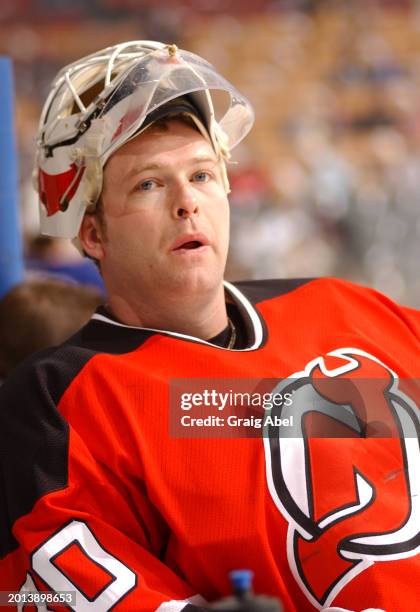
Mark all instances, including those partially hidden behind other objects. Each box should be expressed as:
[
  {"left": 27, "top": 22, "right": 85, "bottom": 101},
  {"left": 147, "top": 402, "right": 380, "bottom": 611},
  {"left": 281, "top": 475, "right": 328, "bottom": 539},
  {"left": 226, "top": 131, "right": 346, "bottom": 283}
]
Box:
[{"left": 81, "top": 121, "right": 229, "bottom": 300}]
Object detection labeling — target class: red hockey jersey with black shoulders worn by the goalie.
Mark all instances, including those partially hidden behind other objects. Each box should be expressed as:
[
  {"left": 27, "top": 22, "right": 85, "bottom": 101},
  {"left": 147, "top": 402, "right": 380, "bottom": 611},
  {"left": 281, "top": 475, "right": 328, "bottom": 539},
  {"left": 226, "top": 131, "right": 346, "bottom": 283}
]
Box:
[{"left": 0, "top": 279, "right": 420, "bottom": 612}]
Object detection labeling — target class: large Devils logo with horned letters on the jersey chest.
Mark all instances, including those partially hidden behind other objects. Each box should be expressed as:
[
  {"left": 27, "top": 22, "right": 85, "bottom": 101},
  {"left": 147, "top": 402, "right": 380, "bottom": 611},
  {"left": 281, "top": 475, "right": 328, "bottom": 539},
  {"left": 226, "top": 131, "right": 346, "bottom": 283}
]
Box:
[{"left": 264, "top": 348, "right": 420, "bottom": 608}]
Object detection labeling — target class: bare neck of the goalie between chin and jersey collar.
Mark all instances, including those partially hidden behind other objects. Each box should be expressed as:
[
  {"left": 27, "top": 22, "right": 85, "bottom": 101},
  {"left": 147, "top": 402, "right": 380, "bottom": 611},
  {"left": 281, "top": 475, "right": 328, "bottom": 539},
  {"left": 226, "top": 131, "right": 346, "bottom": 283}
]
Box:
[{"left": 107, "top": 285, "right": 228, "bottom": 340}]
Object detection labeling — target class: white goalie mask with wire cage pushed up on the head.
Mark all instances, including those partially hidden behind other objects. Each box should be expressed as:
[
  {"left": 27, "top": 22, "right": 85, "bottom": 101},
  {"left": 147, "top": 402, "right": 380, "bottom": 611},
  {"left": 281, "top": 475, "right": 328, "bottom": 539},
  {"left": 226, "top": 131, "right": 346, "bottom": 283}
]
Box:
[{"left": 34, "top": 41, "right": 254, "bottom": 238}]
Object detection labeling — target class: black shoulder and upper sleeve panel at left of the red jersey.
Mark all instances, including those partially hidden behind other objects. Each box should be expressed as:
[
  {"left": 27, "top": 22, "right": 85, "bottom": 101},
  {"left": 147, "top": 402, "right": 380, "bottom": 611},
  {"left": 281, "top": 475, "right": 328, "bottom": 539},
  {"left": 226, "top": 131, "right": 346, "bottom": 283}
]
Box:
[{"left": 0, "top": 320, "right": 154, "bottom": 557}]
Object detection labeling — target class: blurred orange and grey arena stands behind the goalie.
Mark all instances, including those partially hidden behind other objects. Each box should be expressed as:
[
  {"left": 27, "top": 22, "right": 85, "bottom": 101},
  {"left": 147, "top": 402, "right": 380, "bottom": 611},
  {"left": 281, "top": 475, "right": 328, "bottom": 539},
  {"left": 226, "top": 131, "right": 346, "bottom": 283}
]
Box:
[{"left": 0, "top": 0, "right": 420, "bottom": 307}]
